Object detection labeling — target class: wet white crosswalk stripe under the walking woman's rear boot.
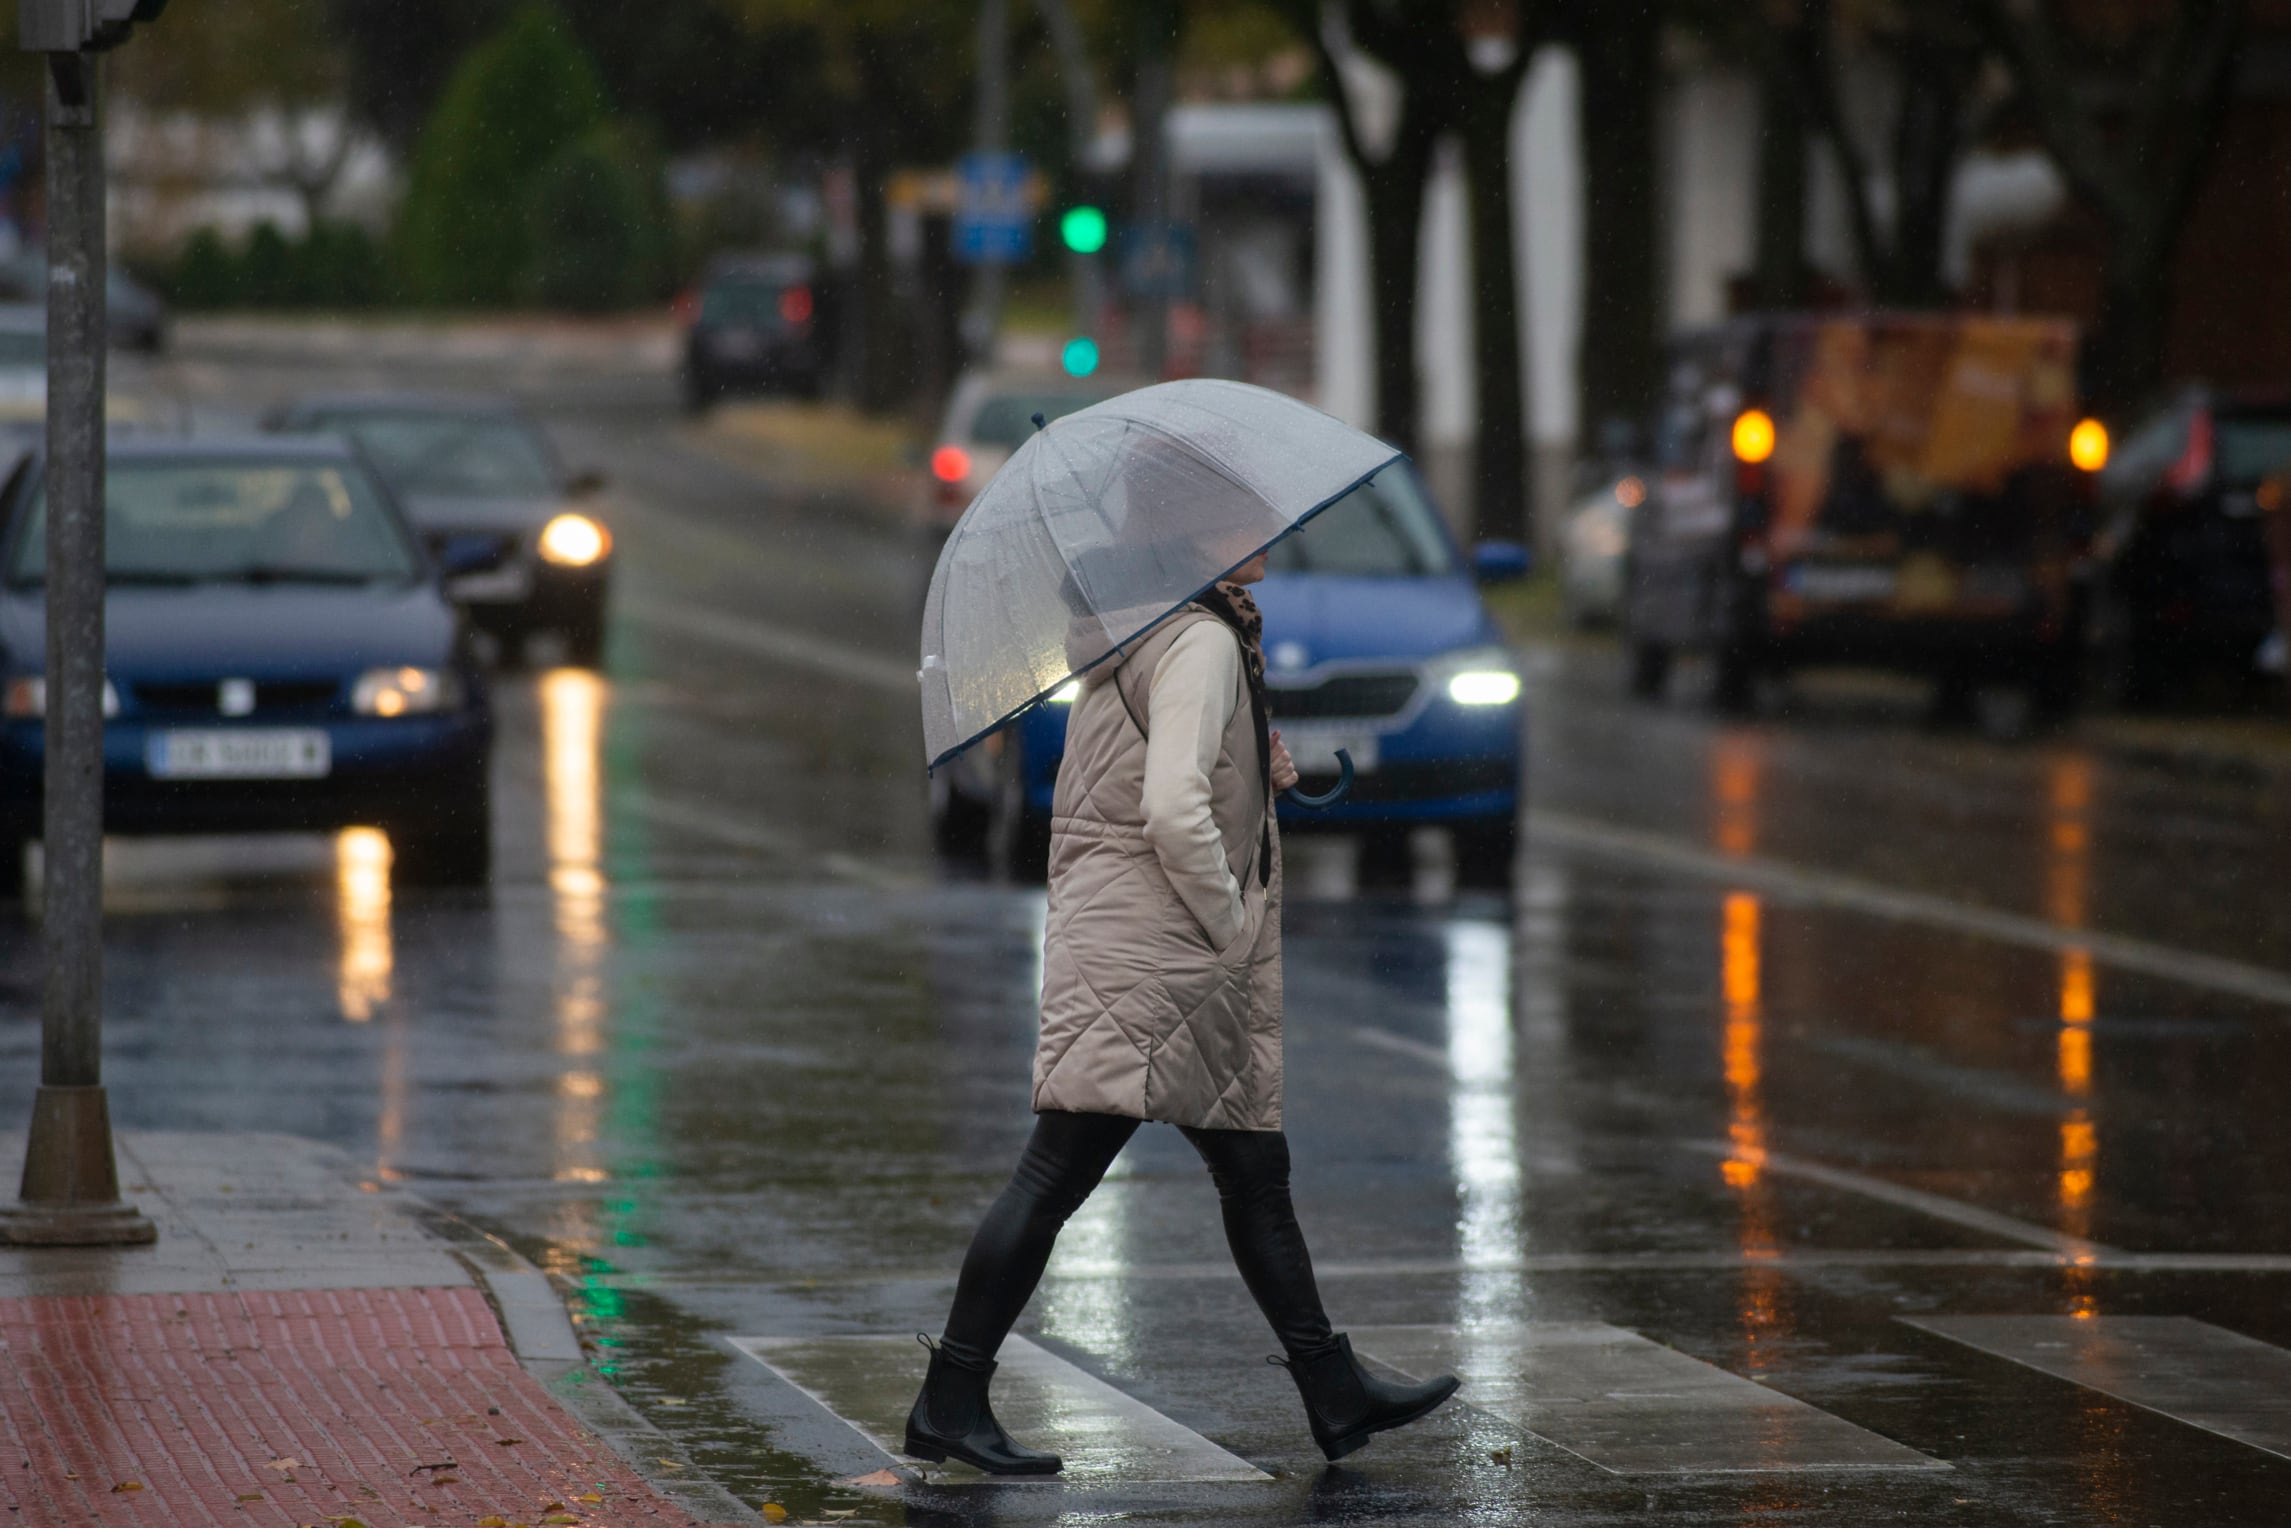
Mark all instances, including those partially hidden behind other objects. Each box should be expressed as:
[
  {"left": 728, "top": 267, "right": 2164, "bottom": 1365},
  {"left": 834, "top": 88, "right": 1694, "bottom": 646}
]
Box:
[{"left": 731, "top": 1333, "right": 1272, "bottom": 1484}]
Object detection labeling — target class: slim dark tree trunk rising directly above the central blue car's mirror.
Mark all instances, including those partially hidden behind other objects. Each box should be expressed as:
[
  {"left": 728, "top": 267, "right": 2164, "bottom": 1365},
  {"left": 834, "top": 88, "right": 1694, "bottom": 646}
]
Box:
[{"left": 1464, "top": 66, "right": 1530, "bottom": 543}]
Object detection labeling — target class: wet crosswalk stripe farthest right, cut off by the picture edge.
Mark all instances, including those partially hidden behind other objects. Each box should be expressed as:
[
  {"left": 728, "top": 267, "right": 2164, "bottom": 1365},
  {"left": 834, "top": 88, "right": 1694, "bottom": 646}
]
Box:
[{"left": 1899, "top": 1315, "right": 2291, "bottom": 1459}]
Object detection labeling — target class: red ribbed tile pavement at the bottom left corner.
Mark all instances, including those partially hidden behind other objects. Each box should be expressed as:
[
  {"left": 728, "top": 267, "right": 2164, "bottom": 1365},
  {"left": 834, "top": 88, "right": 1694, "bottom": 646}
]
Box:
[{"left": 0, "top": 1290, "right": 714, "bottom": 1528}]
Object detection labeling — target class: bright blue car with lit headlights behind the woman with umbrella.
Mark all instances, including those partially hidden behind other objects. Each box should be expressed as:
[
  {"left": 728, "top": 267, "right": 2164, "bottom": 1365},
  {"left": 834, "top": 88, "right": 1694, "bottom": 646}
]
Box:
[{"left": 932, "top": 460, "right": 1526, "bottom": 887}]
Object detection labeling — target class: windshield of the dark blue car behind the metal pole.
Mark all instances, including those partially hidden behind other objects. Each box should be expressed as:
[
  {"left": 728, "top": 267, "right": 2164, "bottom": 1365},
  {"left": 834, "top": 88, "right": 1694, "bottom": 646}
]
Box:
[{"left": 9, "top": 460, "right": 422, "bottom": 584}]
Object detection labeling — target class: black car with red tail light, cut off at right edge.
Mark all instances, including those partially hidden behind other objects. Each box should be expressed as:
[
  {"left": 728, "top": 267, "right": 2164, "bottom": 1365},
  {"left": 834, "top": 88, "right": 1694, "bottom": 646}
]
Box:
[{"left": 2096, "top": 387, "right": 2291, "bottom": 706}]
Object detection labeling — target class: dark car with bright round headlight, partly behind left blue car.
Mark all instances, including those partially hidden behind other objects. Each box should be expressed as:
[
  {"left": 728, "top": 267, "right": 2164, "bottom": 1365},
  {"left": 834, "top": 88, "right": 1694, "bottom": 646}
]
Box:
[{"left": 273, "top": 394, "right": 612, "bottom": 667}]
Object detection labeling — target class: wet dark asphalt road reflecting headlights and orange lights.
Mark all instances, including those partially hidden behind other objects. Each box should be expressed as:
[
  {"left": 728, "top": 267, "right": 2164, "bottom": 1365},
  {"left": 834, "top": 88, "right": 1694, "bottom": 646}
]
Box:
[{"left": 0, "top": 334, "right": 2291, "bottom": 1526}]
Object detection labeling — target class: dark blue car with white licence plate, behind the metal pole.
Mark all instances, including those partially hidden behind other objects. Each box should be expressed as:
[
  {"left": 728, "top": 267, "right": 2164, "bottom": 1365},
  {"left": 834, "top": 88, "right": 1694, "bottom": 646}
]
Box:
[{"left": 0, "top": 435, "right": 493, "bottom": 896}]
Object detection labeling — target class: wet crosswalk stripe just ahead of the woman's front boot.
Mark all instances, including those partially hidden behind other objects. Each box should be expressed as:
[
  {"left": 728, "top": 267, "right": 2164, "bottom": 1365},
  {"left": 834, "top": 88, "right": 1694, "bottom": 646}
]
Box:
[{"left": 1352, "top": 1322, "right": 1947, "bottom": 1475}]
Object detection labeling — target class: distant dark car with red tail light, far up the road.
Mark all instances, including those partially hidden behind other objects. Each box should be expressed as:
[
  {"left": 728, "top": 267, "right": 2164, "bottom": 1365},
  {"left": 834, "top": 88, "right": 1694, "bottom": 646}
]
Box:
[{"left": 678, "top": 254, "right": 834, "bottom": 412}]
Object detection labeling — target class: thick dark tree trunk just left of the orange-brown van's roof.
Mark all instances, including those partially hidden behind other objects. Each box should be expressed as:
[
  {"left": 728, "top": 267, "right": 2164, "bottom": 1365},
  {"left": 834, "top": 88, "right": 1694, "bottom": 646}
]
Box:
[{"left": 1576, "top": 14, "right": 1663, "bottom": 453}]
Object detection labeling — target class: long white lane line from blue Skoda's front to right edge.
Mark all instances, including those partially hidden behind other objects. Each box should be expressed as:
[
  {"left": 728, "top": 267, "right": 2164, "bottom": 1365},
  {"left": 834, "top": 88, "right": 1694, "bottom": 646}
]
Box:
[{"left": 1528, "top": 809, "right": 2291, "bottom": 1010}]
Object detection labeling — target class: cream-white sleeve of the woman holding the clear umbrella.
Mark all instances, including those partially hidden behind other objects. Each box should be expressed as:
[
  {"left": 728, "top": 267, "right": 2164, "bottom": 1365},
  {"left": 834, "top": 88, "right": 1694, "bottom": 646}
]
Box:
[{"left": 1146, "top": 621, "right": 1246, "bottom": 948}]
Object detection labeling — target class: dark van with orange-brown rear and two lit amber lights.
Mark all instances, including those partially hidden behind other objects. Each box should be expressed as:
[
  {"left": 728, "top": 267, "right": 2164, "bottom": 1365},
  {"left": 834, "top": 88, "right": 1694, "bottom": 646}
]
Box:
[{"left": 1622, "top": 314, "right": 2108, "bottom": 715}]
